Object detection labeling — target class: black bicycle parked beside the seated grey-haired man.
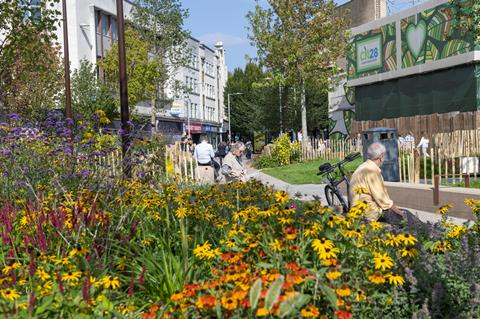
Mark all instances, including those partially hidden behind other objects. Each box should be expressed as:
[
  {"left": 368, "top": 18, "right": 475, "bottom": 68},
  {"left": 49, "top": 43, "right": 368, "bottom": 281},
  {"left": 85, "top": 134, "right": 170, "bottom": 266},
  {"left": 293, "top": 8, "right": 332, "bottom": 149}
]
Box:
[{"left": 317, "top": 152, "right": 361, "bottom": 214}]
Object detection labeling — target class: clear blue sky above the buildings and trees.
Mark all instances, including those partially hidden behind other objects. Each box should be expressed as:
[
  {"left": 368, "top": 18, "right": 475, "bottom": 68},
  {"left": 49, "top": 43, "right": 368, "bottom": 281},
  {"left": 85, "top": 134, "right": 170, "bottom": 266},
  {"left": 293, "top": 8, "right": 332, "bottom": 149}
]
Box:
[{"left": 181, "top": 0, "right": 424, "bottom": 71}]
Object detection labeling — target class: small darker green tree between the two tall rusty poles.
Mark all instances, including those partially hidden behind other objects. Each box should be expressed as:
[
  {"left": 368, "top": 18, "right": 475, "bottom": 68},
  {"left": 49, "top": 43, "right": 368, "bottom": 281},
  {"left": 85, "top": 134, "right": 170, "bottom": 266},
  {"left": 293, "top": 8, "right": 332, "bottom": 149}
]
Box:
[{"left": 72, "top": 60, "right": 117, "bottom": 120}]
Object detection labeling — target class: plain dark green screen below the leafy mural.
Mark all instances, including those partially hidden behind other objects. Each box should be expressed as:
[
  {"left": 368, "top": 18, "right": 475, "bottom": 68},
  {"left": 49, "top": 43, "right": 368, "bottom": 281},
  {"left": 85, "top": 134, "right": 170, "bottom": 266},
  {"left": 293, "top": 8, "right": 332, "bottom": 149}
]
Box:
[{"left": 355, "top": 64, "right": 480, "bottom": 121}]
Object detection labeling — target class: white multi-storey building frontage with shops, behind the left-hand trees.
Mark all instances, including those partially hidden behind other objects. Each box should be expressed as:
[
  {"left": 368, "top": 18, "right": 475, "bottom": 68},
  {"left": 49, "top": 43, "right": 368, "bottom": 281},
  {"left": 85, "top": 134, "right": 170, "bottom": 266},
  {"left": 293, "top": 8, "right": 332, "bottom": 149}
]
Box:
[{"left": 51, "top": 0, "right": 228, "bottom": 142}]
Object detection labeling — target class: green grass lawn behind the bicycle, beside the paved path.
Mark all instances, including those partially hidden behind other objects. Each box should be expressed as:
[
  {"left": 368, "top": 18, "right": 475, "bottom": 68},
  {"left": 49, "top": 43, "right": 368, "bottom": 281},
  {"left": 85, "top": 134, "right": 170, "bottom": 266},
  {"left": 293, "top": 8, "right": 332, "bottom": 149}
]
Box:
[{"left": 262, "top": 158, "right": 363, "bottom": 184}]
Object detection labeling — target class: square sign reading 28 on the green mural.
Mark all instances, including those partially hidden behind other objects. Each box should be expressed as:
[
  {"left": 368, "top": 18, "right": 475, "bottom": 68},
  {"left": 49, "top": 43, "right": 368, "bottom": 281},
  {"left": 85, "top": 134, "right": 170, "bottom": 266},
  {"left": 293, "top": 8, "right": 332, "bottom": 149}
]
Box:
[{"left": 355, "top": 34, "right": 383, "bottom": 73}]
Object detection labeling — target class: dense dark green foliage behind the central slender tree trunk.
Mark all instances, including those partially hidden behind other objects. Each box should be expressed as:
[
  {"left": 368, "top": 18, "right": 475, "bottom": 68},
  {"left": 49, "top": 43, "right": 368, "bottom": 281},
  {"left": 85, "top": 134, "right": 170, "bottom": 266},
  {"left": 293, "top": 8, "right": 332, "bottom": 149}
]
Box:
[{"left": 224, "top": 63, "right": 328, "bottom": 136}]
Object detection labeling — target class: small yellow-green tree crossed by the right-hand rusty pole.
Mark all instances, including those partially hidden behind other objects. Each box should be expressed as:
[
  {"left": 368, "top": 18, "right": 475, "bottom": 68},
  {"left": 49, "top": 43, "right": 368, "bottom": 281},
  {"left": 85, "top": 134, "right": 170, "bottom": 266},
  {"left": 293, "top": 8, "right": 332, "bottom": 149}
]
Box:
[{"left": 98, "top": 26, "right": 161, "bottom": 111}]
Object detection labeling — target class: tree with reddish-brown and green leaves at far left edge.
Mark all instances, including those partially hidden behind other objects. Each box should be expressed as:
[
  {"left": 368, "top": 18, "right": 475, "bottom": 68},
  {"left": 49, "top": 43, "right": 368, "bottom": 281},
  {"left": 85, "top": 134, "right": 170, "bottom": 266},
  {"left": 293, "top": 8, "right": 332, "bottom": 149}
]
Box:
[{"left": 0, "top": 0, "right": 60, "bottom": 117}]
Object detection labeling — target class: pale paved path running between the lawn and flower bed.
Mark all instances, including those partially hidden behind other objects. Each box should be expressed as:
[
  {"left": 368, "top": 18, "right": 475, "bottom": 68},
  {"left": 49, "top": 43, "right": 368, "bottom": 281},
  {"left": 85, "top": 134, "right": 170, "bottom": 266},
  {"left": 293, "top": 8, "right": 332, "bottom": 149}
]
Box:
[{"left": 246, "top": 165, "right": 467, "bottom": 224}]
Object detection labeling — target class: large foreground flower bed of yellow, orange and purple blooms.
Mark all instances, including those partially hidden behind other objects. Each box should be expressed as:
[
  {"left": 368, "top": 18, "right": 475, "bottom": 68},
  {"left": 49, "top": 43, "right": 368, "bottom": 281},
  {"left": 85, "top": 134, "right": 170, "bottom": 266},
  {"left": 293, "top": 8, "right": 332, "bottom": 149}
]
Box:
[{"left": 0, "top": 114, "right": 480, "bottom": 318}]
